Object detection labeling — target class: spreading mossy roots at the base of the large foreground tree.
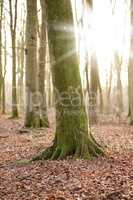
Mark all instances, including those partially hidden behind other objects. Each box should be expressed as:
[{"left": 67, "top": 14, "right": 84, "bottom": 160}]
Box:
[{"left": 32, "top": 134, "right": 104, "bottom": 161}]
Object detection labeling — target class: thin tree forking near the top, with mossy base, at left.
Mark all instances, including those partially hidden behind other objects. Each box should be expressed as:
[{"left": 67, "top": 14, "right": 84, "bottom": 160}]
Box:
[{"left": 9, "top": 0, "right": 18, "bottom": 118}]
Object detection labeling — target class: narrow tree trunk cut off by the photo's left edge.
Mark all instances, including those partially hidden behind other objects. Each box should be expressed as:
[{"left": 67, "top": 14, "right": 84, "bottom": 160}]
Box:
[{"left": 0, "top": 0, "right": 3, "bottom": 109}]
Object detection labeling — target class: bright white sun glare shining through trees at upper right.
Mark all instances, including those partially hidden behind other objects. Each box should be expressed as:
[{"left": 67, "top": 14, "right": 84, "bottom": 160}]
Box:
[{"left": 72, "top": 0, "right": 130, "bottom": 85}]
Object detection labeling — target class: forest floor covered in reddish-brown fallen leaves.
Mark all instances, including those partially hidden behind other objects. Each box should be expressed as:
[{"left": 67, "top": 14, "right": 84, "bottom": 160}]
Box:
[{"left": 0, "top": 116, "right": 133, "bottom": 200}]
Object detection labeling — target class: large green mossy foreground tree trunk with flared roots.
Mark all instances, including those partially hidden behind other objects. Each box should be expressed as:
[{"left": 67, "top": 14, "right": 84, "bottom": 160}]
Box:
[{"left": 32, "top": 0, "right": 103, "bottom": 160}]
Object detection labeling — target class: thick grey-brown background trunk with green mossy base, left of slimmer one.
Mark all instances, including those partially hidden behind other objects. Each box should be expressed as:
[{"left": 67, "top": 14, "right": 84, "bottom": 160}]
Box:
[{"left": 25, "top": 0, "right": 40, "bottom": 127}]
